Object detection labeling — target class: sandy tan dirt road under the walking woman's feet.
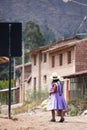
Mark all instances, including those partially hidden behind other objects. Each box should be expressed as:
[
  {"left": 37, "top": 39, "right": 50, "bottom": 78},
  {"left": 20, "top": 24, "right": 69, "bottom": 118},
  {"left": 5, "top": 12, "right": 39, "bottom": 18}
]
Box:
[{"left": 0, "top": 109, "right": 87, "bottom": 130}]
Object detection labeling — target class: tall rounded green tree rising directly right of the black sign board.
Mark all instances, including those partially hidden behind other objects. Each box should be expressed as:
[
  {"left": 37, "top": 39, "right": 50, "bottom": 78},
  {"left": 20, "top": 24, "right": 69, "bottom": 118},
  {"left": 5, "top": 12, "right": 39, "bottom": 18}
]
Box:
[{"left": 23, "top": 21, "right": 44, "bottom": 50}]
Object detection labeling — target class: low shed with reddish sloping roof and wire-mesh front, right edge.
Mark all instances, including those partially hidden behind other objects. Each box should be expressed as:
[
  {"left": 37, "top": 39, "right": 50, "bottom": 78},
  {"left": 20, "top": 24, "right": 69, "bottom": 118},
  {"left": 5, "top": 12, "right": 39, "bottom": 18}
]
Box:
[{"left": 64, "top": 69, "right": 87, "bottom": 100}]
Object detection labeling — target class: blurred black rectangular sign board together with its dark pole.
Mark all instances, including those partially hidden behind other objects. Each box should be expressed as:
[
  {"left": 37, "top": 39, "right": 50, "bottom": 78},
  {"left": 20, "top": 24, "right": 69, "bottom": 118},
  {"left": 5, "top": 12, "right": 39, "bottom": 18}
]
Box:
[{"left": 0, "top": 23, "right": 22, "bottom": 118}]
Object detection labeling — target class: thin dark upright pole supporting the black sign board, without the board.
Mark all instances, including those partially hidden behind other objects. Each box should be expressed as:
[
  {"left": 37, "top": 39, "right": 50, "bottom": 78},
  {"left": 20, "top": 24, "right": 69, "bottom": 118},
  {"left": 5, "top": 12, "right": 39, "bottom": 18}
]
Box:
[{"left": 8, "top": 24, "right": 11, "bottom": 119}]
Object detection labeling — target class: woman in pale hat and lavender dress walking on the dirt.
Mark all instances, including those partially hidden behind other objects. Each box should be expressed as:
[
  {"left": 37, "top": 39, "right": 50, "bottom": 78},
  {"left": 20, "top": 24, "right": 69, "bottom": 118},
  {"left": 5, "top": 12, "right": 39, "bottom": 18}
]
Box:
[{"left": 47, "top": 72, "right": 67, "bottom": 122}]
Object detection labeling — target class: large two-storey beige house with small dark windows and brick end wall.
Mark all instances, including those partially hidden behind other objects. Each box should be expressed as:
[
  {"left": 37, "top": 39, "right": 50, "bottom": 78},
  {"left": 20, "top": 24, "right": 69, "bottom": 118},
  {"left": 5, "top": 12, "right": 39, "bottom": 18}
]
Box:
[{"left": 27, "top": 37, "right": 87, "bottom": 101}]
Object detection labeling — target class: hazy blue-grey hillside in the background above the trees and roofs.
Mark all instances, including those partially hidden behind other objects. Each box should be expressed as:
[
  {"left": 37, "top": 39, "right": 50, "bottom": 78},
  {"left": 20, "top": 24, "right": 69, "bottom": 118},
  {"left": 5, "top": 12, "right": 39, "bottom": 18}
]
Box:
[{"left": 0, "top": 0, "right": 87, "bottom": 37}]
